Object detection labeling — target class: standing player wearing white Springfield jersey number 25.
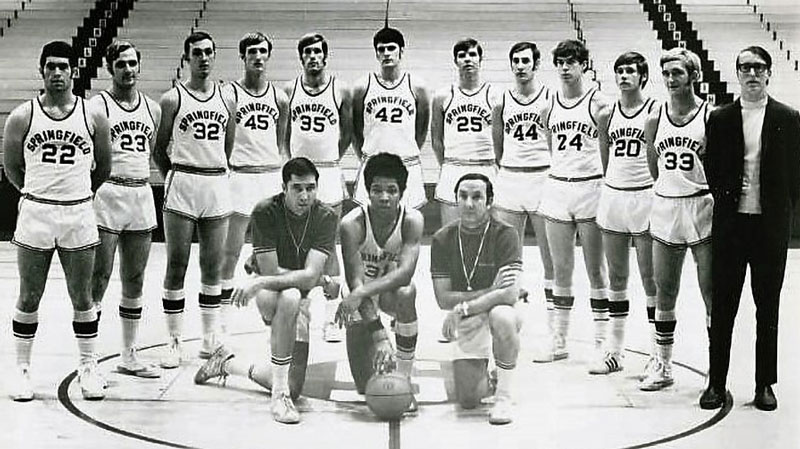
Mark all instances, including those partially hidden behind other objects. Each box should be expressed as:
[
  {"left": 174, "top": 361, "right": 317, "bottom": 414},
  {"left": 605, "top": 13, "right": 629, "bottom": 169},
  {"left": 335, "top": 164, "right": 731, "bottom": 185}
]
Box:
[{"left": 431, "top": 38, "right": 497, "bottom": 226}]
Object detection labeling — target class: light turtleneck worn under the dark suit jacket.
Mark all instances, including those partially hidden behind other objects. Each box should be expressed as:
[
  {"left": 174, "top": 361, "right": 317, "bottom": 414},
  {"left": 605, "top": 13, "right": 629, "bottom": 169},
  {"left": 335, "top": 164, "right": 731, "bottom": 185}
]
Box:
[{"left": 739, "top": 96, "right": 767, "bottom": 214}]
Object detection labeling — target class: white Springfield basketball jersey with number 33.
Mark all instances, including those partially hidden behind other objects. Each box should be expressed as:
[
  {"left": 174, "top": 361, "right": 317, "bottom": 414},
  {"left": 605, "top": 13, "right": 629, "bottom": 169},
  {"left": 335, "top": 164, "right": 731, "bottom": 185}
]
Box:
[{"left": 654, "top": 101, "right": 708, "bottom": 198}]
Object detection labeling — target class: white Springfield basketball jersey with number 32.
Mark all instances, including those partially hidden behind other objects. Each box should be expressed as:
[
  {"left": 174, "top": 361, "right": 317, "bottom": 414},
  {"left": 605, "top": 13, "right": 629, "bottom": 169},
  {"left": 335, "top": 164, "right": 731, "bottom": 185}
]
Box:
[{"left": 170, "top": 83, "right": 228, "bottom": 168}]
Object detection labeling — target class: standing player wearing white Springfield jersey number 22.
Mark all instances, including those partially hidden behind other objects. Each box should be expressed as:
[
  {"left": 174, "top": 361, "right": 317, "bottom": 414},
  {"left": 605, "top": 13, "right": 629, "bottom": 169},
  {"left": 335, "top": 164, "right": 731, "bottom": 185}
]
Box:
[{"left": 3, "top": 41, "right": 111, "bottom": 401}]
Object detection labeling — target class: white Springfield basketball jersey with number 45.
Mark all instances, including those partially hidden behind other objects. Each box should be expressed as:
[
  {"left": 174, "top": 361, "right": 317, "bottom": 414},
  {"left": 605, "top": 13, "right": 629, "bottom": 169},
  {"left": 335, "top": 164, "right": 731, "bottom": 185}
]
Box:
[{"left": 230, "top": 81, "right": 281, "bottom": 167}]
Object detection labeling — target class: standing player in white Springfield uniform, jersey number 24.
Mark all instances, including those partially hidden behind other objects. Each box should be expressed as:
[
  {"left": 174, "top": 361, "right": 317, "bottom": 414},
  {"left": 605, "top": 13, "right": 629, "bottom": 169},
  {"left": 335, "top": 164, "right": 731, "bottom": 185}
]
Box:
[{"left": 534, "top": 40, "right": 610, "bottom": 362}]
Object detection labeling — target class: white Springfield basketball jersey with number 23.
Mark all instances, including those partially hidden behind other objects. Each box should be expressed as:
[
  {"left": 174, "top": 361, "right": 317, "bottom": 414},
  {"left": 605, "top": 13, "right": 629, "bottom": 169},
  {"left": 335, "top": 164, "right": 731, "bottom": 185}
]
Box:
[{"left": 100, "top": 91, "right": 156, "bottom": 179}]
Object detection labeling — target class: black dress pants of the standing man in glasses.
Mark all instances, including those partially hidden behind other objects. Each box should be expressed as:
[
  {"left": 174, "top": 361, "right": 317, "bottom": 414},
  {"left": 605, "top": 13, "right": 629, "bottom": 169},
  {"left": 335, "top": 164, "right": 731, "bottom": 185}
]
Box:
[{"left": 709, "top": 213, "right": 790, "bottom": 388}]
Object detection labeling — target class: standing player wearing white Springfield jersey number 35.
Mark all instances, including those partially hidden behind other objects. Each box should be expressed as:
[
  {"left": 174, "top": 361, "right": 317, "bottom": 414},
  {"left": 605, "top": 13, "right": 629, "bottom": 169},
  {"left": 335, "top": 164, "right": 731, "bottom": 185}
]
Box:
[{"left": 285, "top": 33, "right": 352, "bottom": 343}]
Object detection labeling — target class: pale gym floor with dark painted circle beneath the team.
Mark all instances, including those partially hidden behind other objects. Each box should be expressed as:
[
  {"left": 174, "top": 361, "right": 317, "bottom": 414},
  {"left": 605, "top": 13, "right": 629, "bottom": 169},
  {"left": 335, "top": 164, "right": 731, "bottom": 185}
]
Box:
[{"left": 0, "top": 243, "right": 800, "bottom": 449}]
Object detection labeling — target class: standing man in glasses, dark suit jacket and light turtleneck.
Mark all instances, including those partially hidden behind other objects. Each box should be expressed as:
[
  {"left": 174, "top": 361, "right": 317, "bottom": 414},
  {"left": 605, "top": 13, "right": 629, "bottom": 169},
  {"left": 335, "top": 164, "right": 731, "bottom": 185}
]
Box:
[{"left": 700, "top": 47, "right": 800, "bottom": 410}]
